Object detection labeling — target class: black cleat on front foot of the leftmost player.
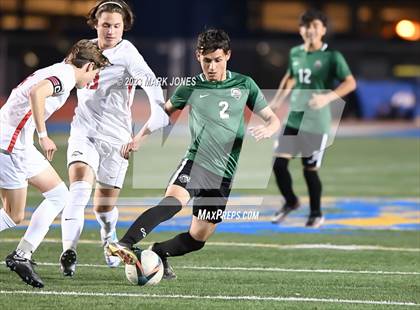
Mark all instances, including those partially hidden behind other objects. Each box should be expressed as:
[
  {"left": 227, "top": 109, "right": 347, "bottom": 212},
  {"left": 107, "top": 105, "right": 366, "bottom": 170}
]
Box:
[{"left": 6, "top": 251, "right": 44, "bottom": 288}]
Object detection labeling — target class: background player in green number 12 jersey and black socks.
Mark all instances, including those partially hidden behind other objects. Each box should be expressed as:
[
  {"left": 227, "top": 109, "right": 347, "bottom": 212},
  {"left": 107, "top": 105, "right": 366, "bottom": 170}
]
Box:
[{"left": 270, "top": 10, "right": 356, "bottom": 227}]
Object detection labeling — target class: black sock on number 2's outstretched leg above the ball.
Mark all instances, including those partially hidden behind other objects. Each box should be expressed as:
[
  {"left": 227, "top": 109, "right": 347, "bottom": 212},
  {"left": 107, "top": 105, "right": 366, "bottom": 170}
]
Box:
[{"left": 120, "top": 197, "right": 182, "bottom": 247}]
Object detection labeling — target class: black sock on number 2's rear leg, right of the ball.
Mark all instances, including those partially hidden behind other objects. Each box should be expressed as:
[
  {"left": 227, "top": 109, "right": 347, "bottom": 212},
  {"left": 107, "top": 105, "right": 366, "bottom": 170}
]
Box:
[{"left": 153, "top": 232, "right": 206, "bottom": 257}]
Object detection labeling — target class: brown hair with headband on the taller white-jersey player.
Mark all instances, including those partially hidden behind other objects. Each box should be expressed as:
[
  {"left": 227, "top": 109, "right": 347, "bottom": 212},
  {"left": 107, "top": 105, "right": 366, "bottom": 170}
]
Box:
[{"left": 87, "top": 0, "right": 134, "bottom": 31}]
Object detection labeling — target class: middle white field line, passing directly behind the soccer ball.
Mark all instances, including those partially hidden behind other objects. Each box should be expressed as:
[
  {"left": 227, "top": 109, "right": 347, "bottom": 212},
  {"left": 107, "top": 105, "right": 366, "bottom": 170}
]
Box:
[{"left": 0, "top": 262, "right": 420, "bottom": 276}]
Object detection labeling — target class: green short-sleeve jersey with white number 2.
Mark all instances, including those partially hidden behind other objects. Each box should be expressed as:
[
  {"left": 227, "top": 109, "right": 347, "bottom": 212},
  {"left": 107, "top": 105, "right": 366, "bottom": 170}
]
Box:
[{"left": 171, "top": 71, "right": 267, "bottom": 178}]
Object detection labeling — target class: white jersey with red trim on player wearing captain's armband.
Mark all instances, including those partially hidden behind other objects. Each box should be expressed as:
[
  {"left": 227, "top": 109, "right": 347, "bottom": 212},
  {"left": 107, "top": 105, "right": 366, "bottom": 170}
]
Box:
[{"left": 0, "top": 62, "right": 76, "bottom": 153}]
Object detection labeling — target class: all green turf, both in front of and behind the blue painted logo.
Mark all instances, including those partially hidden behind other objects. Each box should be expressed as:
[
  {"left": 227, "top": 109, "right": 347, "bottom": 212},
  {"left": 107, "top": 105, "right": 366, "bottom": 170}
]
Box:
[{"left": 0, "top": 135, "right": 420, "bottom": 309}]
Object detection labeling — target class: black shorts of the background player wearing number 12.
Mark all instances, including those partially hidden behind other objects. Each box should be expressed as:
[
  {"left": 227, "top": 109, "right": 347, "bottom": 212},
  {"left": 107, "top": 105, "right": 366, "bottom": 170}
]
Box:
[{"left": 274, "top": 126, "right": 328, "bottom": 168}]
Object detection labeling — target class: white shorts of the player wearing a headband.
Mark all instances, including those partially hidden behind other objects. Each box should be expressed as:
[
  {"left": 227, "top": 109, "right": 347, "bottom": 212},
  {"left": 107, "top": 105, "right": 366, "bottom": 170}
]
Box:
[{"left": 67, "top": 136, "right": 128, "bottom": 188}]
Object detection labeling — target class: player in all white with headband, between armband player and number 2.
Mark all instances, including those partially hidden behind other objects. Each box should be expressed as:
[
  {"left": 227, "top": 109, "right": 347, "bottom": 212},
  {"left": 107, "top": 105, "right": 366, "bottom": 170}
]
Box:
[{"left": 60, "top": 0, "right": 169, "bottom": 276}]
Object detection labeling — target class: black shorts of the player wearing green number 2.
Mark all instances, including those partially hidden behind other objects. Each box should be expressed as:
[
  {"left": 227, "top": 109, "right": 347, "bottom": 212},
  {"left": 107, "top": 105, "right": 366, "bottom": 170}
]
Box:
[{"left": 169, "top": 159, "right": 232, "bottom": 224}]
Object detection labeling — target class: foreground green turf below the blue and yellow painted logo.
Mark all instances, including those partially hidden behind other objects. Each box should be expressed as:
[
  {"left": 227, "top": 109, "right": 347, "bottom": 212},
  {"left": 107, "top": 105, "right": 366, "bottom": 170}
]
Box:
[{"left": 0, "top": 230, "right": 420, "bottom": 309}]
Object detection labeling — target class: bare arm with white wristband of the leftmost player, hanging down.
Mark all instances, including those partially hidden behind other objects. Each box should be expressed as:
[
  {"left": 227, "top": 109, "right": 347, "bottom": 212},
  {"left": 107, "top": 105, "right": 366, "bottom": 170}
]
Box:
[{"left": 29, "top": 80, "right": 57, "bottom": 161}]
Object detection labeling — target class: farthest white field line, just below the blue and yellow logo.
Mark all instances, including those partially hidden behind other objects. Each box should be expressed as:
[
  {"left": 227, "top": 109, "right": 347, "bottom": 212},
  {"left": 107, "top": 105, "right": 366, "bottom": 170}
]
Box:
[{"left": 0, "top": 238, "right": 420, "bottom": 252}]
